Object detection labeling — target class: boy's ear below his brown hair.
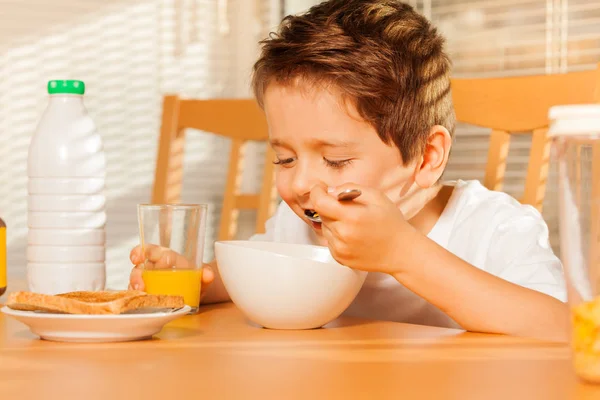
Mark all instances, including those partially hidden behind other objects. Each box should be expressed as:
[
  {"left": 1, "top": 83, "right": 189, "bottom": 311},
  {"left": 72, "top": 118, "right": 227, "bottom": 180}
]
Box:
[{"left": 415, "top": 125, "right": 452, "bottom": 188}]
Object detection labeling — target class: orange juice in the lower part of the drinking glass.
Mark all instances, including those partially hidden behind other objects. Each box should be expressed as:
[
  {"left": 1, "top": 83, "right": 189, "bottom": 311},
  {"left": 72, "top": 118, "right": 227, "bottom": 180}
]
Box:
[{"left": 142, "top": 269, "right": 202, "bottom": 310}]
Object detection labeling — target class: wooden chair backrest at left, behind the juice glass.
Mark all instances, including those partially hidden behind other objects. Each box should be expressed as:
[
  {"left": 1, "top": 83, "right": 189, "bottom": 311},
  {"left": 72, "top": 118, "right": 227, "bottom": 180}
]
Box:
[{"left": 152, "top": 96, "right": 276, "bottom": 240}]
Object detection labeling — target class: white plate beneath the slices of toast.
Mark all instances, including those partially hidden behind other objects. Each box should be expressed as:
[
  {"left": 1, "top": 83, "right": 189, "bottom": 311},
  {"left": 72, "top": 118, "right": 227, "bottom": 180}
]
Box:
[{"left": 1, "top": 306, "right": 190, "bottom": 343}]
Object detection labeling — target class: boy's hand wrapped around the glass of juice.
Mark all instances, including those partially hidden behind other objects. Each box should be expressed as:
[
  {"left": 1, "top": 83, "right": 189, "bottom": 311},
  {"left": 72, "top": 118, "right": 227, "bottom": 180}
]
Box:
[{"left": 129, "top": 245, "right": 215, "bottom": 294}]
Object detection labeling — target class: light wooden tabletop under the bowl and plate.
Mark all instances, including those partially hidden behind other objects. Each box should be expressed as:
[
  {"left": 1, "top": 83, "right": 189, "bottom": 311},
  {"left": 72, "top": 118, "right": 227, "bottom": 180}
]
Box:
[{"left": 0, "top": 303, "right": 600, "bottom": 400}]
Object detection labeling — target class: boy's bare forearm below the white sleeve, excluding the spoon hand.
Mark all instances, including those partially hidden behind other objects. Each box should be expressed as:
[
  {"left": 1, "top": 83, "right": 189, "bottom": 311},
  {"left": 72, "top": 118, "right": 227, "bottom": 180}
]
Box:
[{"left": 392, "top": 231, "right": 568, "bottom": 341}]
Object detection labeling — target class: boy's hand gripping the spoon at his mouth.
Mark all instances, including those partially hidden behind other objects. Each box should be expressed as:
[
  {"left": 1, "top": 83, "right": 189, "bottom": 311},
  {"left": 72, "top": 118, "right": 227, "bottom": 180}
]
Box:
[{"left": 310, "top": 184, "right": 416, "bottom": 273}]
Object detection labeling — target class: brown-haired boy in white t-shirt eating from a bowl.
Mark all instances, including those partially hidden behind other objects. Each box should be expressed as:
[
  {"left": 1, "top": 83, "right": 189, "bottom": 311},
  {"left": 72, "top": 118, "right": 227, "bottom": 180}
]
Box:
[{"left": 131, "top": 0, "right": 568, "bottom": 340}]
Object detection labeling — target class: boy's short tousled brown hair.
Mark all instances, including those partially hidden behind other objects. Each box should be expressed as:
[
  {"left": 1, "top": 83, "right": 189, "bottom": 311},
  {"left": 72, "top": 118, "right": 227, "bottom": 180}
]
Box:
[{"left": 252, "top": 0, "right": 455, "bottom": 163}]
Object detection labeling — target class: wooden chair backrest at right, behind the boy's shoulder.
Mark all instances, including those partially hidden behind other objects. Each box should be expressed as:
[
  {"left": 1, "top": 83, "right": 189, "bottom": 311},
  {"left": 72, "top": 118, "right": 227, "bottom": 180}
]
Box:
[{"left": 451, "top": 64, "right": 600, "bottom": 211}]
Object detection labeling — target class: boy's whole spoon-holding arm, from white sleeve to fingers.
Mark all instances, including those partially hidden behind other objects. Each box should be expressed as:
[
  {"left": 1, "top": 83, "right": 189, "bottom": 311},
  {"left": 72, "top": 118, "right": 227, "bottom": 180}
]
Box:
[{"left": 311, "top": 184, "right": 568, "bottom": 341}]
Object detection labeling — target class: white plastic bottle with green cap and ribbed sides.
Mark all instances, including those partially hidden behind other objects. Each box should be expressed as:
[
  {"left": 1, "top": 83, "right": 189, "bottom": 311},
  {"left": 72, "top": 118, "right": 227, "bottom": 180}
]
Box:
[{"left": 27, "top": 80, "right": 106, "bottom": 294}]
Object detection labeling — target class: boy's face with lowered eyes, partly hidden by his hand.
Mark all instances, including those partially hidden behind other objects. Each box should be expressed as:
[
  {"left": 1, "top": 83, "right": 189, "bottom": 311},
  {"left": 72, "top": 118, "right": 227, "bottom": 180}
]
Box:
[{"left": 264, "top": 84, "right": 415, "bottom": 236}]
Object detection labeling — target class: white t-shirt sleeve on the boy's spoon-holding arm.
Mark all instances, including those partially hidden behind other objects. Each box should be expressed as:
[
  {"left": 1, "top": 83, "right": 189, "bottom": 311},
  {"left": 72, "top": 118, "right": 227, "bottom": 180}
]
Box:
[{"left": 485, "top": 206, "right": 567, "bottom": 302}]
